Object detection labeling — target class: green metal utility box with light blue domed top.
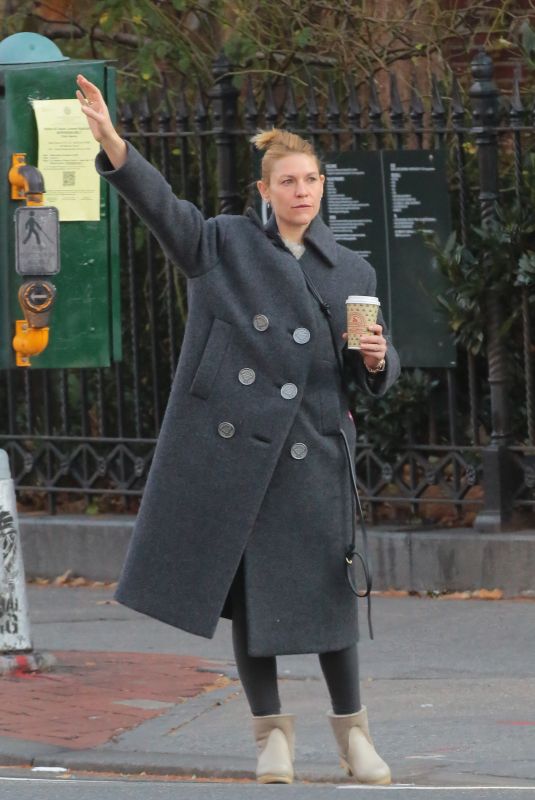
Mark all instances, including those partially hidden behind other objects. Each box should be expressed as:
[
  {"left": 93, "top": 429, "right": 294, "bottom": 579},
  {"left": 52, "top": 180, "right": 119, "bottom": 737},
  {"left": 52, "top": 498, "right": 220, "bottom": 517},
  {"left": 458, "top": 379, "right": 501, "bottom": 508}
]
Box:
[{"left": 0, "top": 33, "right": 121, "bottom": 369}]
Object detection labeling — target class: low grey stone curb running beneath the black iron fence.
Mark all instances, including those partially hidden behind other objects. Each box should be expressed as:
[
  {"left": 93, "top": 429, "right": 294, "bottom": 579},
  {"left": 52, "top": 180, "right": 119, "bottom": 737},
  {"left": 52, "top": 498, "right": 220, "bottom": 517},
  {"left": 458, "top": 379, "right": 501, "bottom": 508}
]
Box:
[{"left": 19, "top": 514, "right": 535, "bottom": 597}]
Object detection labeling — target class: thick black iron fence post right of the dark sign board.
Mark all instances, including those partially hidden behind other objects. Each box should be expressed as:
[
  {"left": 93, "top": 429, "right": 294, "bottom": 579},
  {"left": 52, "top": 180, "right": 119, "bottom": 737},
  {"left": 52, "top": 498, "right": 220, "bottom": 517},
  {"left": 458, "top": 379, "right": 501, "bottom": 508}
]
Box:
[{"left": 470, "top": 52, "right": 513, "bottom": 531}]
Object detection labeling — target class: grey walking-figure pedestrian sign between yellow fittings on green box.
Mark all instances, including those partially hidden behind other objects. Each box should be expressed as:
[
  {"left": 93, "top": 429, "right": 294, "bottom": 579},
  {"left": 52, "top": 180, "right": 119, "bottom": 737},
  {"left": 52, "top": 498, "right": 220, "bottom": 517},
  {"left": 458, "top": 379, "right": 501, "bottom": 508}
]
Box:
[{"left": 15, "top": 206, "right": 60, "bottom": 275}]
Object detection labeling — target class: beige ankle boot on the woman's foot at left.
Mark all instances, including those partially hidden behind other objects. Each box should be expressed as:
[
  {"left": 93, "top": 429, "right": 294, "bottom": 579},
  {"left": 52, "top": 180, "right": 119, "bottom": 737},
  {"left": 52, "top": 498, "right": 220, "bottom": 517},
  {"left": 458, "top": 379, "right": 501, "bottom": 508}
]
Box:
[{"left": 253, "top": 714, "right": 294, "bottom": 783}]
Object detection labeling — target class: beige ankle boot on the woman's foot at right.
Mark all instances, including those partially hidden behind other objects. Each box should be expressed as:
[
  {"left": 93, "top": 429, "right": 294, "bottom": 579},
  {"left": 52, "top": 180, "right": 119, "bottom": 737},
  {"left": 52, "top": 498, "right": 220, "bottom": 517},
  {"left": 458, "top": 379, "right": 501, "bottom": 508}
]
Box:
[{"left": 329, "top": 706, "right": 392, "bottom": 784}]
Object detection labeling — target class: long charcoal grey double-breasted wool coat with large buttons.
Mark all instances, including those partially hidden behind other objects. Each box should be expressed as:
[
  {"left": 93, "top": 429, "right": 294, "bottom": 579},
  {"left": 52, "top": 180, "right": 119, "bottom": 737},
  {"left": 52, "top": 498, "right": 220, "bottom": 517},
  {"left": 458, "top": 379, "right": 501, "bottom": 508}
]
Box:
[{"left": 96, "top": 145, "right": 399, "bottom": 656}]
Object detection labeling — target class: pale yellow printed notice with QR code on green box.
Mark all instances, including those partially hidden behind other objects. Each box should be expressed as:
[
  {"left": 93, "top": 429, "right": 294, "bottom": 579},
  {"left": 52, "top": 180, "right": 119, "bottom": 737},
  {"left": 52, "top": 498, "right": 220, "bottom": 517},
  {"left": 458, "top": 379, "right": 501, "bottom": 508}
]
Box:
[{"left": 32, "top": 99, "right": 100, "bottom": 222}]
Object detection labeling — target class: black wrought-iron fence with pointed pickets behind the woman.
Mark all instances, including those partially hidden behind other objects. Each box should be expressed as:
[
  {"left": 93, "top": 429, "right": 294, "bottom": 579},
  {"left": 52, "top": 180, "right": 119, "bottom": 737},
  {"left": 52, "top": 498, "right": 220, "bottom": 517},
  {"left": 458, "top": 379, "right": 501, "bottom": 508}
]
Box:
[{"left": 0, "top": 48, "right": 535, "bottom": 529}]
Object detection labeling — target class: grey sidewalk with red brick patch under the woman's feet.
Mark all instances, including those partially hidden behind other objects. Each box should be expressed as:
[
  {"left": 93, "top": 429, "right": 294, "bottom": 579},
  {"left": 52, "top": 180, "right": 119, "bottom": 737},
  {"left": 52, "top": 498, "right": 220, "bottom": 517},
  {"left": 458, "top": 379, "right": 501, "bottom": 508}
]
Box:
[{"left": 0, "top": 586, "right": 535, "bottom": 790}]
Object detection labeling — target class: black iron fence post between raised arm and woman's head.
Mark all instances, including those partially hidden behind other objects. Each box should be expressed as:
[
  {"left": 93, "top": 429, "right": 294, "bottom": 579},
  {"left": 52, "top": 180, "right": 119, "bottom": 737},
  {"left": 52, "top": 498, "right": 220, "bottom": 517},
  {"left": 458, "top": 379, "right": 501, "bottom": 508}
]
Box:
[{"left": 209, "top": 53, "right": 241, "bottom": 214}]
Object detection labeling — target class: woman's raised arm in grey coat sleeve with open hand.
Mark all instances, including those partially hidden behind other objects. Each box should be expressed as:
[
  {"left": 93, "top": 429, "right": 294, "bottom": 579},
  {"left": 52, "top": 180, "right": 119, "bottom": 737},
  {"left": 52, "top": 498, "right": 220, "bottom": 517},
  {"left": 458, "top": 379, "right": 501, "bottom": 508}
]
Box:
[{"left": 76, "top": 75, "right": 221, "bottom": 278}]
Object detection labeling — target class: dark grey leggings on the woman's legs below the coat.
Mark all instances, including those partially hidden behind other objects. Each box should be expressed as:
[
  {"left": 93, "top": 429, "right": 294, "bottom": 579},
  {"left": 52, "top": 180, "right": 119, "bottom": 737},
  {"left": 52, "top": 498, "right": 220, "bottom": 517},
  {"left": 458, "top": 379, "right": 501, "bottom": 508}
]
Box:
[{"left": 231, "top": 565, "right": 361, "bottom": 717}]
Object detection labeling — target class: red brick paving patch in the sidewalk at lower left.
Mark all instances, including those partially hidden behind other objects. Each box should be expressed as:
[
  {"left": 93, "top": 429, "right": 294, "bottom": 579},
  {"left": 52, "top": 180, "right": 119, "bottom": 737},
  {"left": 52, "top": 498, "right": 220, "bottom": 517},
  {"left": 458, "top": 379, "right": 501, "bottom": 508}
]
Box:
[{"left": 0, "top": 651, "right": 229, "bottom": 763}]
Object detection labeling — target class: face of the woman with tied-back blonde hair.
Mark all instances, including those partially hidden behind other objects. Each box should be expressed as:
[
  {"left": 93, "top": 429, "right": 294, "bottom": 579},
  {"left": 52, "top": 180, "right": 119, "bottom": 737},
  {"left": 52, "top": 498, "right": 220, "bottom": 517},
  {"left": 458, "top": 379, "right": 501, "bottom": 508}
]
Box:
[{"left": 257, "top": 153, "right": 325, "bottom": 233}]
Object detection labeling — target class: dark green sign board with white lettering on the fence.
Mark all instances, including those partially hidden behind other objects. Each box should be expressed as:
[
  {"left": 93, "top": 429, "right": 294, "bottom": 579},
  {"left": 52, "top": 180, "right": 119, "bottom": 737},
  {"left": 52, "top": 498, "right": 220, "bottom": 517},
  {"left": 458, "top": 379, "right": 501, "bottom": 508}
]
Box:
[{"left": 323, "top": 150, "right": 456, "bottom": 367}]
